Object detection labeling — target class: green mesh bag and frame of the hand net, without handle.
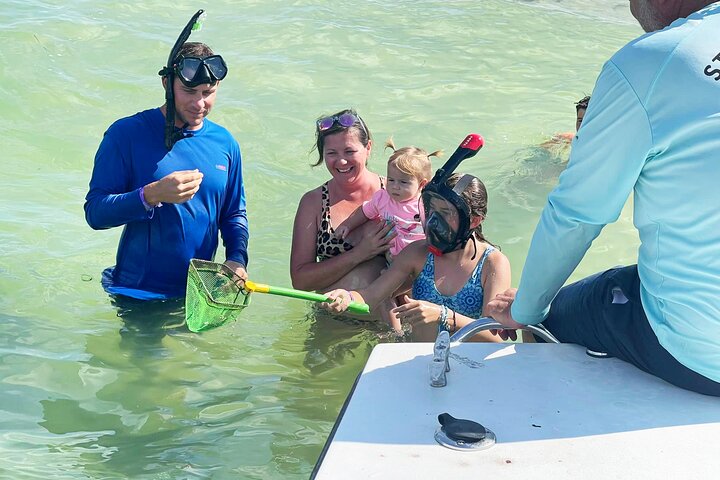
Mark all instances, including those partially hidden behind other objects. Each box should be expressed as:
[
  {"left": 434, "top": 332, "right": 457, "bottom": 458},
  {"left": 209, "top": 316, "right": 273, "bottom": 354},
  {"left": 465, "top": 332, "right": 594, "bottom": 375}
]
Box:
[{"left": 185, "top": 259, "right": 250, "bottom": 332}]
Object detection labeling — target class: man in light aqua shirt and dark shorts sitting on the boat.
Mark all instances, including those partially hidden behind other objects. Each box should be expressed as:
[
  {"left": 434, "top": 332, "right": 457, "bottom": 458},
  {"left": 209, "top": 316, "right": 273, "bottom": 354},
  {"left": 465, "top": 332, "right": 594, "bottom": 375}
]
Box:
[{"left": 491, "top": 0, "right": 720, "bottom": 396}]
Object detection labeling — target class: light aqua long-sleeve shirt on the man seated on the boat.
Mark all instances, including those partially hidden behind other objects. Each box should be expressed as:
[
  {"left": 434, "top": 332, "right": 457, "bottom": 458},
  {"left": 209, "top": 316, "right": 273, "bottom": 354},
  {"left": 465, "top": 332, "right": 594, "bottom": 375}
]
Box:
[{"left": 512, "top": 2, "right": 720, "bottom": 381}]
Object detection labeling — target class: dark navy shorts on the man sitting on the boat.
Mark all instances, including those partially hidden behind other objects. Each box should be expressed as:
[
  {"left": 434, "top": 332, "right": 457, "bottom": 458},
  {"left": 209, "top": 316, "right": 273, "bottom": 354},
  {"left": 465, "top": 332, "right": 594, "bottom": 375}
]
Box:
[{"left": 543, "top": 265, "right": 720, "bottom": 396}]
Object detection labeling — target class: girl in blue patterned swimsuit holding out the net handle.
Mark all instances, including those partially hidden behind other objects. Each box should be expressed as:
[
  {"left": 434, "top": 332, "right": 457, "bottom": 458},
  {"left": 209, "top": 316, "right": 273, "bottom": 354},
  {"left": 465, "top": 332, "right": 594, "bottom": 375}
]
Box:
[{"left": 326, "top": 174, "right": 510, "bottom": 341}]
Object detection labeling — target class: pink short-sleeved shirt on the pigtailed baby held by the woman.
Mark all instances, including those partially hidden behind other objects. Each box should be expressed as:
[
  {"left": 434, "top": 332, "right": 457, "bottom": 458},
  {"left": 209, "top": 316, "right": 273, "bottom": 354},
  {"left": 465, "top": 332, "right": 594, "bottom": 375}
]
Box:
[{"left": 363, "top": 189, "right": 425, "bottom": 256}]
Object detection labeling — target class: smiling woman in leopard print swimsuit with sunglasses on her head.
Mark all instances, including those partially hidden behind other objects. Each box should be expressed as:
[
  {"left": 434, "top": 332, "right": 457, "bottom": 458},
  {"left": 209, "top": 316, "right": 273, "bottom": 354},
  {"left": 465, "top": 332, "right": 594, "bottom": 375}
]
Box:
[{"left": 290, "top": 110, "right": 394, "bottom": 322}]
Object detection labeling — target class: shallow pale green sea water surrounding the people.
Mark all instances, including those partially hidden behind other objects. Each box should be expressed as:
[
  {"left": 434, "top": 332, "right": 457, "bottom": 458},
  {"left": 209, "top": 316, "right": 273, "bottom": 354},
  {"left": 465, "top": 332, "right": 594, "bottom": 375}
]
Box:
[{"left": 0, "top": 0, "right": 640, "bottom": 479}]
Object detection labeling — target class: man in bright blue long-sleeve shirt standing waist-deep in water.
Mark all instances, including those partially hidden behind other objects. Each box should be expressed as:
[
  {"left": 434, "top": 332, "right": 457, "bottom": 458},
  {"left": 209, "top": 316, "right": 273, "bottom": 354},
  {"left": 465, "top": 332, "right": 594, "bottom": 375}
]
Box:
[{"left": 85, "top": 42, "right": 248, "bottom": 300}]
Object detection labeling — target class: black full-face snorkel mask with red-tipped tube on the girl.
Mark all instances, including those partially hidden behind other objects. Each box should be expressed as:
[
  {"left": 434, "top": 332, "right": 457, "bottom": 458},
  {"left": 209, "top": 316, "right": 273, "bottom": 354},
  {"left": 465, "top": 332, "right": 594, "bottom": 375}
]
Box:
[{"left": 421, "top": 133, "right": 485, "bottom": 256}]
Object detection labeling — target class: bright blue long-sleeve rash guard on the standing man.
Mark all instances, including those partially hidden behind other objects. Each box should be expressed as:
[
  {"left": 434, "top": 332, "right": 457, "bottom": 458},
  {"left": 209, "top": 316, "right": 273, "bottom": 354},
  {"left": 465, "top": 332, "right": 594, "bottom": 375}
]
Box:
[{"left": 85, "top": 108, "right": 249, "bottom": 298}]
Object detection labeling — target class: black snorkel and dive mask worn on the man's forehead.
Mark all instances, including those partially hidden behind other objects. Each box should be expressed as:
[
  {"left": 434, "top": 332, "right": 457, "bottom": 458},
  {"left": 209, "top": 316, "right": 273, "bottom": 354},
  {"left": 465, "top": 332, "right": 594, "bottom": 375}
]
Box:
[{"left": 158, "top": 10, "right": 227, "bottom": 150}]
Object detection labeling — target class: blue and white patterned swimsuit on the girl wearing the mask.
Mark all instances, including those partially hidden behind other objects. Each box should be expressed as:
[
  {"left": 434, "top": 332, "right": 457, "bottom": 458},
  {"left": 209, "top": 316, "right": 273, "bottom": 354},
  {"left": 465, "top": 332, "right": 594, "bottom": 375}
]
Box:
[{"left": 412, "top": 246, "right": 495, "bottom": 324}]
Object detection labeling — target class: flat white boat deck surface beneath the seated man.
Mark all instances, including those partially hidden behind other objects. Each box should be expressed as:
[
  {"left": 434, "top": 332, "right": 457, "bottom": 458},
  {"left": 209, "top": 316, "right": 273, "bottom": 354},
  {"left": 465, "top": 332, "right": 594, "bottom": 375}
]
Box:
[{"left": 314, "top": 343, "right": 720, "bottom": 480}]
